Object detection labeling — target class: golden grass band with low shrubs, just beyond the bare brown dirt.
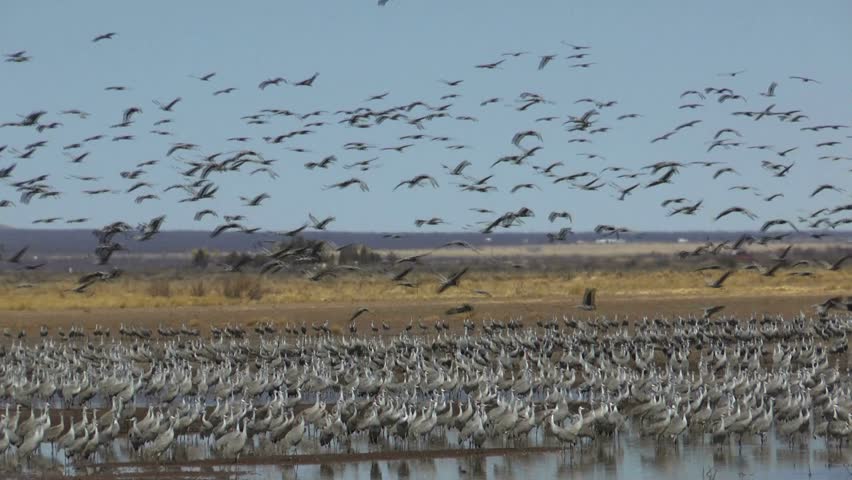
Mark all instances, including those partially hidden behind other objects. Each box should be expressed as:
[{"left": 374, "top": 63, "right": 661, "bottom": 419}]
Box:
[{"left": 0, "top": 270, "right": 852, "bottom": 311}]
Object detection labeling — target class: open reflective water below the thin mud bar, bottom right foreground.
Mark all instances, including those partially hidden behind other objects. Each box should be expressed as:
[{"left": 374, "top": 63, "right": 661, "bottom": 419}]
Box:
[{"left": 240, "top": 442, "right": 850, "bottom": 480}]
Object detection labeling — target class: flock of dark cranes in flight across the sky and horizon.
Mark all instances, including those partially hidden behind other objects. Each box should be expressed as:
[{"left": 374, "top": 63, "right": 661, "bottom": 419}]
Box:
[{"left": 0, "top": 32, "right": 852, "bottom": 312}]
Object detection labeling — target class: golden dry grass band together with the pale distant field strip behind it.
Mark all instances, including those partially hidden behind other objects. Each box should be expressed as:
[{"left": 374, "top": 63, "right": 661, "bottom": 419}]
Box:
[{"left": 0, "top": 243, "right": 852, "bottom": 312}]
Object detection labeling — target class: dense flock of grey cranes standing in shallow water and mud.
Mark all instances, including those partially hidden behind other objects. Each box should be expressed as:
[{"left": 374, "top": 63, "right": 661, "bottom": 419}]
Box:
[{"left": 0, "top": 314, "right": 852, "bottom": 466}]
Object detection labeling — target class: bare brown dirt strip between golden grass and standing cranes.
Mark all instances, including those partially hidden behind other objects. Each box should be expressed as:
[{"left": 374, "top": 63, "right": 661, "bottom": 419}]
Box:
[{"left": 0, "top": 283, "right": 848, "bottom": 337}]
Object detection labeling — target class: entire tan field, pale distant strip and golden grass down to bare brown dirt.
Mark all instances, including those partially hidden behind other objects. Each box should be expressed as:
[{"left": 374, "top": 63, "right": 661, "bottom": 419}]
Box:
[{"left": 0, "top": 243, "right": 852, "bottom": 332}]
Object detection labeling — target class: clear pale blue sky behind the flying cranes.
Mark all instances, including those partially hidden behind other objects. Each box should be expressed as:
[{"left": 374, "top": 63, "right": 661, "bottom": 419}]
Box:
[{"left": 0, "top": 0, "right": 852, "bottom": 231}]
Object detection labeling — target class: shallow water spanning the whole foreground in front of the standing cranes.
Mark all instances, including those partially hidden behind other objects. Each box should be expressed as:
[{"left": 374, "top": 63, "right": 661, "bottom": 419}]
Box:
[{"left": 8, "top": 436, "right": 852, "bottom": 480}]
